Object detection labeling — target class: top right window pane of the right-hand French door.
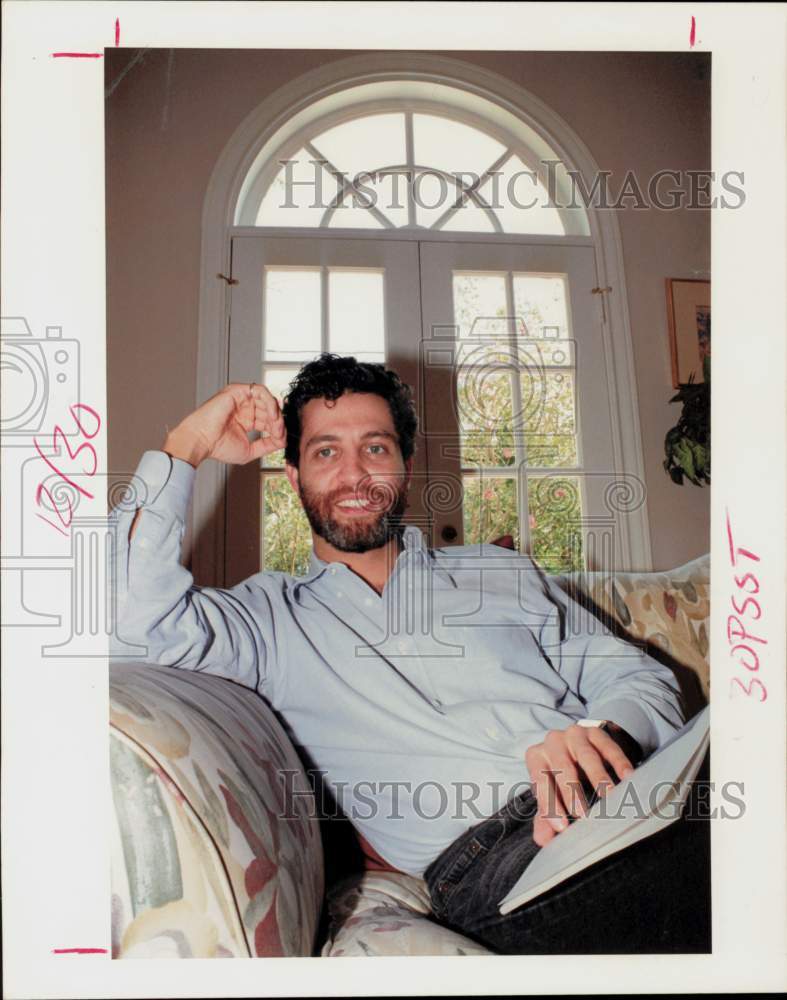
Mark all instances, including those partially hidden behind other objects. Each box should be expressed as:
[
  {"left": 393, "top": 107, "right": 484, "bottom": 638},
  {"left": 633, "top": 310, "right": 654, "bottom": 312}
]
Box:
[{"left": 514, "top": 274, "right": 574, "bottom": 356}]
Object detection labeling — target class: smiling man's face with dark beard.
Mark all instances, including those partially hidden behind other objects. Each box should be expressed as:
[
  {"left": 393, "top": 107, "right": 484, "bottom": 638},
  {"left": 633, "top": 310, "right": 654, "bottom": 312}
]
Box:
[{"left": 285, "top": 392, "right": 412, "bottom": 552}]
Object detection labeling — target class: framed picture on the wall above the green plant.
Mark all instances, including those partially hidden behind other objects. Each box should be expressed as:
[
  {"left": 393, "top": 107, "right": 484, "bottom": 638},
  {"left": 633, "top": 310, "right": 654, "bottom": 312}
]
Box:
[{"left": 667, "top": 278, "right": 710, "bottom": 389}]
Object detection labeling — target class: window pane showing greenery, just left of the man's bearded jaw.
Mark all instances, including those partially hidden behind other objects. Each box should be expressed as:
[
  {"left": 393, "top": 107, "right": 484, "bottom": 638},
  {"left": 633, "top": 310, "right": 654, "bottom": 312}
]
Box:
[{"left": 262, "top": 475, "right": 312, "bottom": 576}]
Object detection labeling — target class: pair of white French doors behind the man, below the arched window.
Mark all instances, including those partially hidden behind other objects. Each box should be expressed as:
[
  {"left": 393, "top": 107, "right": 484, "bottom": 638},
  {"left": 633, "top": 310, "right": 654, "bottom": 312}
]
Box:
[{"left": 225, "top": 230, "right": 618, "bottom": 584}]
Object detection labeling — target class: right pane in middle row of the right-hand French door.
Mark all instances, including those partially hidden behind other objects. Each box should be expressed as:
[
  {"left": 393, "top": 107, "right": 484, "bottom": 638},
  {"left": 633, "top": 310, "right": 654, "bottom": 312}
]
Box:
[{"left": 520, "top": 371, "right": 578, "bottom": 466}]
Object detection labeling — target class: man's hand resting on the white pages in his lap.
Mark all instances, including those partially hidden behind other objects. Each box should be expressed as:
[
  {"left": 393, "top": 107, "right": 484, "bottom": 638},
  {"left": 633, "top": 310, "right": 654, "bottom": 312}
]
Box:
[{"left": 525, "top": 726, "right": 634, "bottom": 847}]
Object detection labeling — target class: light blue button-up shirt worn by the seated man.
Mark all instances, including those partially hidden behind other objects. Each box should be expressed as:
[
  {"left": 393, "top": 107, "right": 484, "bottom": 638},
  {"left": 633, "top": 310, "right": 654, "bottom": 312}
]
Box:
[{"left": 115, "top": 451, "right": 683, "bottom": 875}]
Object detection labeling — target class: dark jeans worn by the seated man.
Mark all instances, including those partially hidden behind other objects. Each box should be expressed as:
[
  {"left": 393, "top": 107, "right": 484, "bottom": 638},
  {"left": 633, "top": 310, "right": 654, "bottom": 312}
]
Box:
[{"left": 424, "top": 757, "right": 711, "bottom": 955}]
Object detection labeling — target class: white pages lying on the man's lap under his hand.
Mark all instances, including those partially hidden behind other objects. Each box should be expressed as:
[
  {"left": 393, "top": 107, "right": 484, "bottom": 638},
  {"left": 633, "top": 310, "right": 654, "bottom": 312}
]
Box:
[{"left": 499, "top": 708, "right": 710, "bottom": 914}]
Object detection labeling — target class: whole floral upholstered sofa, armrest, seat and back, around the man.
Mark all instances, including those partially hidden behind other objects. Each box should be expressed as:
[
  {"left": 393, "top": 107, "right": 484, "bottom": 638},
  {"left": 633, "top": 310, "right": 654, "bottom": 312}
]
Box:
[{"left": 110, "top": 556, "right": 710, "bottom": 958}]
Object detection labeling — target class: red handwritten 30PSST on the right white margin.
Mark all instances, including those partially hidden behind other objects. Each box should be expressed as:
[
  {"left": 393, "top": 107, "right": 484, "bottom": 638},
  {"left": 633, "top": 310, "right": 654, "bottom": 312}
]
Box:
[{"left": 727, "top": 511, "right": 768, "bottom": 701}]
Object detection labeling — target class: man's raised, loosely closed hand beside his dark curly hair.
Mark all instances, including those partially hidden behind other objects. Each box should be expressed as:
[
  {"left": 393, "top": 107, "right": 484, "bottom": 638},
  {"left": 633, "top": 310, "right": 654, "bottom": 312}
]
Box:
[{"left": 163, "top": 382, "right": 285, "bottom": 468}]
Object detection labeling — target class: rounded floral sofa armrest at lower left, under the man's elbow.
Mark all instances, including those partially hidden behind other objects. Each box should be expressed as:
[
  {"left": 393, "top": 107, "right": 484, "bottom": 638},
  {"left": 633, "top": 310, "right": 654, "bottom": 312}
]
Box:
[{"left": 110, "top": 663, "right": 324, "bottom": 957}]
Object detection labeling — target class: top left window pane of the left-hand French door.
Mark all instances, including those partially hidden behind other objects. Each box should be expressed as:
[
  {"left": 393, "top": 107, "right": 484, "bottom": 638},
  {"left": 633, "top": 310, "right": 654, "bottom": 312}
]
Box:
[{"left": 263, "top": 267, "right": 321, "bottom": 361}]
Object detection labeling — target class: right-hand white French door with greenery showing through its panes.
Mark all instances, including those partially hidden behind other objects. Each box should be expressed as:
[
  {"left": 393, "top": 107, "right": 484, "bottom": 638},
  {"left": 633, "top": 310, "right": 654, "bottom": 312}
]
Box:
[{"left": 420, "top": 242, "right": 616, "bottom": 571}]
